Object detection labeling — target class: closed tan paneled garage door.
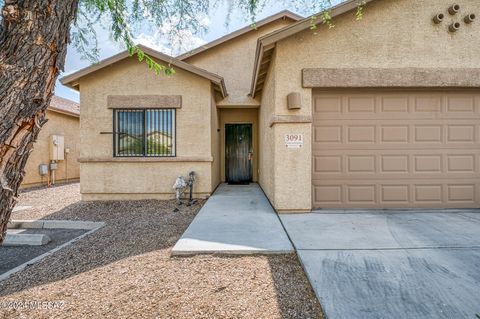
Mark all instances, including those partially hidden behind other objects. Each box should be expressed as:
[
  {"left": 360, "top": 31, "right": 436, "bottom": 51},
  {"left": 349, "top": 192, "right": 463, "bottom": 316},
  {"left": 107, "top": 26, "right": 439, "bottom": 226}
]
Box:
[{"left": 312, "top": 90, "right": 480, "bottom": 208}]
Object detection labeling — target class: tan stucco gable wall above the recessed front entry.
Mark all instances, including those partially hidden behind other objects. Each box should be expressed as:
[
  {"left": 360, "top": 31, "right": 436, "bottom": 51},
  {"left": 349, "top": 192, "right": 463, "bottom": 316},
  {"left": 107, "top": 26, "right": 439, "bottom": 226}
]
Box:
[{"left": 185, "top": 19, "right": 292, "bottom": 105}]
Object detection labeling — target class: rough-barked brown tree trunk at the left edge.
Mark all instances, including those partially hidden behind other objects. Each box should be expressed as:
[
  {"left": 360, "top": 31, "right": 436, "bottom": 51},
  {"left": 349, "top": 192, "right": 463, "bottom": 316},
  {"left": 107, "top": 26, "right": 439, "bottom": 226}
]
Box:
[{"left": 0, "top": 0, "right": 78, "bottom": 244}]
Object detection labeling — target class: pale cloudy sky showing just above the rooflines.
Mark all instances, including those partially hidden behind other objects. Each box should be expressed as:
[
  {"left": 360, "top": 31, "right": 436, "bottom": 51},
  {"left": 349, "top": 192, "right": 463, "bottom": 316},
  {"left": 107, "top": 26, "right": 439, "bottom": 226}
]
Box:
[{"left": 55, "top": 1, "right": 302, "bottom": 102}]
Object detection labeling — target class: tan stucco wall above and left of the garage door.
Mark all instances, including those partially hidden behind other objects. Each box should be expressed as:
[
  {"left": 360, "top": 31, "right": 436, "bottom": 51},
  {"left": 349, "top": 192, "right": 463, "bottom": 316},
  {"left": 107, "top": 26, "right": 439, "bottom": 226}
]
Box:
[{"left": 266, "top": 0, "right": 480, "bottom": 210}]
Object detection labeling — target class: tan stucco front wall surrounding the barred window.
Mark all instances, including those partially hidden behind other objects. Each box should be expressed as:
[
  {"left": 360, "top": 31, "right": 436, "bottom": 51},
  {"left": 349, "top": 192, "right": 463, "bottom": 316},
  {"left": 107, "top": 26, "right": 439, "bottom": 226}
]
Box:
[{"left": 80, "top": 58, "right": 213, "bottom": 200}]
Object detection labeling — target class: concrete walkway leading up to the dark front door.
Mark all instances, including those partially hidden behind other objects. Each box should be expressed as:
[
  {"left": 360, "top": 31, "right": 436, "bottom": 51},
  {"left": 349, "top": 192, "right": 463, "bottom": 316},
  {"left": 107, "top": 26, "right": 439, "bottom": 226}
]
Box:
[{"left": 172, "top": 184, "right": 294, "bottom": 255}]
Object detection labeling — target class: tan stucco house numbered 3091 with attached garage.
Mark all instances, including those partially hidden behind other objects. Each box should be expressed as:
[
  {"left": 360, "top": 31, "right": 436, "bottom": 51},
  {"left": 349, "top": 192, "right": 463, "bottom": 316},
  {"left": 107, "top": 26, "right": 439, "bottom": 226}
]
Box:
[{"left": 62, "top": 0, "right": 480, "bottom": 212}]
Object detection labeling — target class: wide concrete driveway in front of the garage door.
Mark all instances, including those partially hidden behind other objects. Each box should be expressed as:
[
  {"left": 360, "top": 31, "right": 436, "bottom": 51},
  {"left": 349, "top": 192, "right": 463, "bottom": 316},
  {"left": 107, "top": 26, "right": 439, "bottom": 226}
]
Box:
[{"left": 280, "top": 210, "right": 480, "bottom": 319}]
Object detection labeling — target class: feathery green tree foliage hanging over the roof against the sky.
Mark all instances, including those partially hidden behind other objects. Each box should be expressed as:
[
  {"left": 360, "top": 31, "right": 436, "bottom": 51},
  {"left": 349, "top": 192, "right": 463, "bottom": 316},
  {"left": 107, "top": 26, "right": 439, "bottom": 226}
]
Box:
[{"left": 0, "top": 0, "right": 364, "bottom": 75}]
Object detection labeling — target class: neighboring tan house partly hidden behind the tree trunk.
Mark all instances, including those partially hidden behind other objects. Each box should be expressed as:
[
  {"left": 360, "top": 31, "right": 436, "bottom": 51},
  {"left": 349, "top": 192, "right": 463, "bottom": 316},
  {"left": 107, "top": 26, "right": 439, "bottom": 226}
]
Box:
[{"left": 21, "top": 96, "right": 80, "bottom": 188}]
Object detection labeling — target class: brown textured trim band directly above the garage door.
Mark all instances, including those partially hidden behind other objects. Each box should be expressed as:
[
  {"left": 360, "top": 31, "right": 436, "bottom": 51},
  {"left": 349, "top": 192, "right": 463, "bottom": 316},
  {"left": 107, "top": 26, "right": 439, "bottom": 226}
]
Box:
[{"left": 302, "top": 68, "right": 480, "bottom": 88}]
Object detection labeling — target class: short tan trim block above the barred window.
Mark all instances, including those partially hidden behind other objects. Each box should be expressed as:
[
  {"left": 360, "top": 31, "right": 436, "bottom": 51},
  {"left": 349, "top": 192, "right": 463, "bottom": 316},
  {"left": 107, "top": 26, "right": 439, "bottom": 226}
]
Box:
[{"left": 107, "top": 95, "right": 182, "bottom": 109}]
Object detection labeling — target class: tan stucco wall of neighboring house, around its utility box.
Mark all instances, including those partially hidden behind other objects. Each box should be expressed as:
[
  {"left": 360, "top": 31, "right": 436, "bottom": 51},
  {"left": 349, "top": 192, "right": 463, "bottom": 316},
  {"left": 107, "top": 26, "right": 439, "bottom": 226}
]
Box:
[{"left": 22, "top": 111, "right": 80, "bottom": 187}]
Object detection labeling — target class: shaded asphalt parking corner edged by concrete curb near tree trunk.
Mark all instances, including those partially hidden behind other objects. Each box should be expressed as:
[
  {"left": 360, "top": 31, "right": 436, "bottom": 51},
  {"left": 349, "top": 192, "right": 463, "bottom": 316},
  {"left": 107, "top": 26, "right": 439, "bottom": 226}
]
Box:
[{"left": 0, "top": 229, "right": 87, "bottom": 275}]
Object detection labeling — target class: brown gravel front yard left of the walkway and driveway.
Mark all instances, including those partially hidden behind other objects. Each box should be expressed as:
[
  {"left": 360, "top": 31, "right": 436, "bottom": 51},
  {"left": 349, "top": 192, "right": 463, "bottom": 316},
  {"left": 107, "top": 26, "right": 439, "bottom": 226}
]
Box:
[{"left": 0, "top": 184, "right": 322, "bottom": 318}]
